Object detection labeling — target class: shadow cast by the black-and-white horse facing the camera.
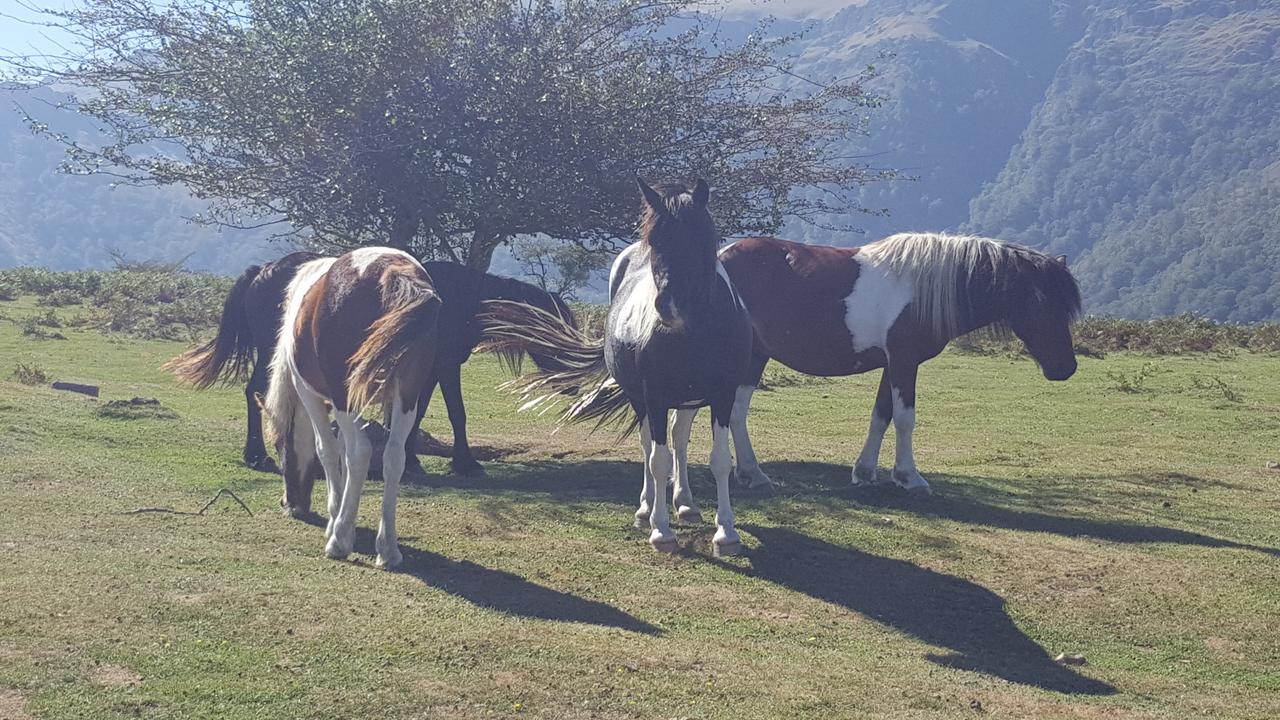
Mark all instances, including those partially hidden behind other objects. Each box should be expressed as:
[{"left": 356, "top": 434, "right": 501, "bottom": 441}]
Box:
[{"left": 721, "top": 525, "right": 1116, "bottom": 694}]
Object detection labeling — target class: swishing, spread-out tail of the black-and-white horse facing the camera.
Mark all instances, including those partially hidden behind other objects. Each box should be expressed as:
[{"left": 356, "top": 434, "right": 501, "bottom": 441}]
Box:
[{"left": 476, "top": 300, "right": 640, "bottom": 434}]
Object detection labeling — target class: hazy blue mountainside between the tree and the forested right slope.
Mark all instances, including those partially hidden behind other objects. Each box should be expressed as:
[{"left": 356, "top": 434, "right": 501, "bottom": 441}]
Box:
[{"left": 787, "top": 0, "right": 1083, "bottom": 245}]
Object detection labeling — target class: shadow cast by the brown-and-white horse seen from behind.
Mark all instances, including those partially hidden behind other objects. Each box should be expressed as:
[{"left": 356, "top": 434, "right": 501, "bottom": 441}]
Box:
[{"left": 298, "top": 520, "right": 659, "bottom": 635}]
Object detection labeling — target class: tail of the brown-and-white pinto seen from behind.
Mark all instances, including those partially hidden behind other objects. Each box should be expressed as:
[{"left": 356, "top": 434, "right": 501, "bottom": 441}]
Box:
[{"left": 347, "top": 265, "right": 440, "bottom": 411}]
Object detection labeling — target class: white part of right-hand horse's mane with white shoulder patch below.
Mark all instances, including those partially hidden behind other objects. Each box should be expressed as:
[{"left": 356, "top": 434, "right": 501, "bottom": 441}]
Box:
[{"left": 858, "top": 233, "right": 1012, "bottom": 338}]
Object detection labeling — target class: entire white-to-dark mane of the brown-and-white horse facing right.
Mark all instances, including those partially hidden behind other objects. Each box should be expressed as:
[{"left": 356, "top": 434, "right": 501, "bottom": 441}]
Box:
[{"left": 858, "top": 233, "right": 1080, "bottom": 338}]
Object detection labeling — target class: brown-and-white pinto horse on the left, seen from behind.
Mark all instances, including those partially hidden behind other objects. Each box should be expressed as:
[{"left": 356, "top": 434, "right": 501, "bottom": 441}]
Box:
[{"left": 262, "top": 247, "right": 440, "bottom": 566}]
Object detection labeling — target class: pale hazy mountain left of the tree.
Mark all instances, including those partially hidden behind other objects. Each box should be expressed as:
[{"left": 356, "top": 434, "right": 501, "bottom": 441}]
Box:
[{"left": 0, "top": 86, "right": 284, "bottom": 274}]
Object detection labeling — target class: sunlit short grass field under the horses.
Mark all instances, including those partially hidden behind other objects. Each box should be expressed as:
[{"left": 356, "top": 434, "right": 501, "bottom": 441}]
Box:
[{"left": 0, "top": 299, "right": 1280, "bottom": 719}]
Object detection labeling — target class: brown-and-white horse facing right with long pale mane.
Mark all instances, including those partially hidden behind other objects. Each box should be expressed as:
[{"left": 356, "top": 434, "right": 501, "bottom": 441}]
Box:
[{"left": 719, "top": 233, "right": 1080, "bottom": 495}]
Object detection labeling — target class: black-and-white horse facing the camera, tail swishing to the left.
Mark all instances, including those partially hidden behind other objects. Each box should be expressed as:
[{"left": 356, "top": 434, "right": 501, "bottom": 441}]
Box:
[{"left": 485, "top": 179, "right": 751, "bottom": 555}]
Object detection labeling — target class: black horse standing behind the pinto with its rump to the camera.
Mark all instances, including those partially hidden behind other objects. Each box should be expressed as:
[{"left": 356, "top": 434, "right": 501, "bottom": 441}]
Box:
[{"left": 165, "top": 252, "right": 577, "bottom": 481}]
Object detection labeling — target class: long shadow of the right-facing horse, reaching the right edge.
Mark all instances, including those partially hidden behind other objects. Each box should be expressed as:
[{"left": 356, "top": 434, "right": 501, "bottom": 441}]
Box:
[{"left": 765, "top": 462, "right": 1280, "bottom": 556}]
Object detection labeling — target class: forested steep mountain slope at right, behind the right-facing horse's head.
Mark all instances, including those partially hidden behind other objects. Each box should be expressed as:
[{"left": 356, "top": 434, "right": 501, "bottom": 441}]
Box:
[{"left": 969, "top": 0, "right": 1280, "bottom": 322}]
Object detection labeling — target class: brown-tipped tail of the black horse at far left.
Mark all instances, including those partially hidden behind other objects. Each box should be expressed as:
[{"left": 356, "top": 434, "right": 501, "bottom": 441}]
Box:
[{"left": 163, "top": 265, "right": 262, "bottom": 389}]
